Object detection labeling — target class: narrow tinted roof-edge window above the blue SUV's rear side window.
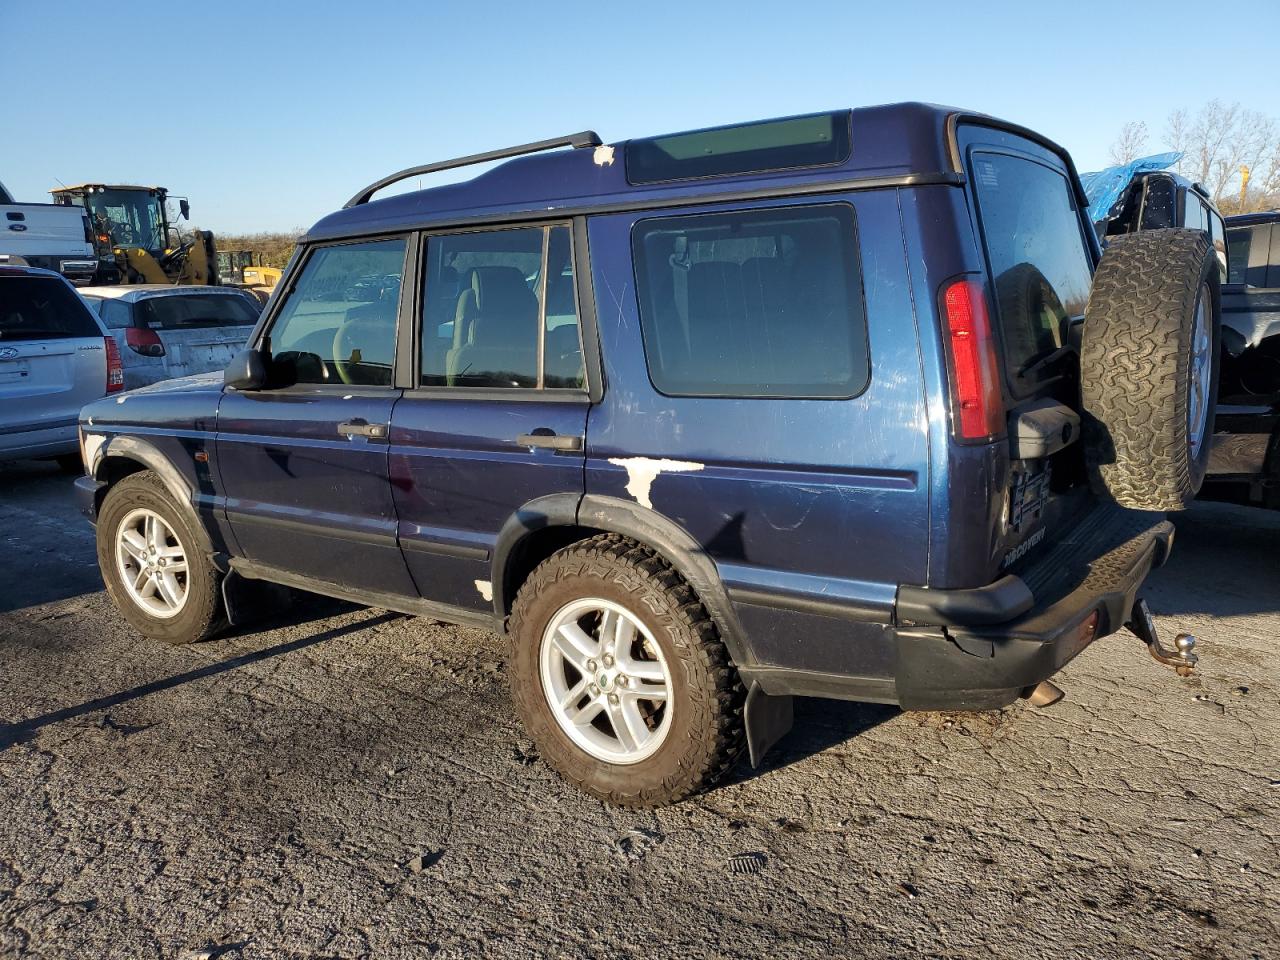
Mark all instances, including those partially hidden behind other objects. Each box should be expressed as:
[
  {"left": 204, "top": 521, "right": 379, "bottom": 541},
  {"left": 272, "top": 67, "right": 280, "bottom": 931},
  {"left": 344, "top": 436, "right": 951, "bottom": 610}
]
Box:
[{"left": 626, "top": 111, "right": 850, "bottom": 183}]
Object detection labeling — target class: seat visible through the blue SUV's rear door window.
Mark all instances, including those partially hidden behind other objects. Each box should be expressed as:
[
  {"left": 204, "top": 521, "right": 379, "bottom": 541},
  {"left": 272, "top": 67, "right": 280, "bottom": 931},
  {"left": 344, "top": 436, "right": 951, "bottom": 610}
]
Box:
[{"left": 444, "top": 266, "right": 538, "bottom": 387}]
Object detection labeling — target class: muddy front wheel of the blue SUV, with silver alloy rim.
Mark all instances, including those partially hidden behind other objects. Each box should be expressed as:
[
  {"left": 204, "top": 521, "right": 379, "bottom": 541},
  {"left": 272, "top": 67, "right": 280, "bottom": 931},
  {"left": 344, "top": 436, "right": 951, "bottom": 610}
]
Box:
[{"left": 97, "top": 471, "right": 223, "bottom": 644}]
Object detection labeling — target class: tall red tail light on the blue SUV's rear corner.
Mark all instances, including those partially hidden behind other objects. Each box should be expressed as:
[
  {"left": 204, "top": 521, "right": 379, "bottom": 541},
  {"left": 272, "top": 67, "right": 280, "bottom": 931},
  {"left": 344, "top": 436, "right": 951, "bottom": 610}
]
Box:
[{"left": 942, "top": 279, "right": 1005, "bottom": 440}]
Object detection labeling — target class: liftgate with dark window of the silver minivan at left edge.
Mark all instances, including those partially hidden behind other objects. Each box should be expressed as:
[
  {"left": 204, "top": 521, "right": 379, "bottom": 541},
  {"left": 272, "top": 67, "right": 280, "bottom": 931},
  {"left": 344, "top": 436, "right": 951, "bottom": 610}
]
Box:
[{"left": 0, "top": 275, "right": 106, "bottom": 436}]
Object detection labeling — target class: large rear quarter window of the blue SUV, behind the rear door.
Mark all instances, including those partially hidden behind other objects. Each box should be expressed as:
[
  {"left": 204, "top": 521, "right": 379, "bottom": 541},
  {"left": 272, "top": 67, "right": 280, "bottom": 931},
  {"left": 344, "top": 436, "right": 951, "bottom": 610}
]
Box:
[{"left": 631, "top": 204, "right": 870, "bottom": 398}]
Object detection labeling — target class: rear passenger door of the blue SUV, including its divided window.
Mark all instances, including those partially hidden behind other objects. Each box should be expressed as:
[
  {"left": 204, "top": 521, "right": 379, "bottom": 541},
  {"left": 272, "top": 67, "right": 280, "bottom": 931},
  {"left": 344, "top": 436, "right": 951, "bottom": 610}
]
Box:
[{"left": 390, "top": 223, "right": 599, "bottom": 612}]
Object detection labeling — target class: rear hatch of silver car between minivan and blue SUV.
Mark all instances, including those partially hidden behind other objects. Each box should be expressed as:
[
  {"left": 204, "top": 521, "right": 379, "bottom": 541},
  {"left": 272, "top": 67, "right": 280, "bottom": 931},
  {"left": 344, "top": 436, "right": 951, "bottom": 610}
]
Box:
[{"left": 135, "top": 291, "right": 261, "bottom": 376}]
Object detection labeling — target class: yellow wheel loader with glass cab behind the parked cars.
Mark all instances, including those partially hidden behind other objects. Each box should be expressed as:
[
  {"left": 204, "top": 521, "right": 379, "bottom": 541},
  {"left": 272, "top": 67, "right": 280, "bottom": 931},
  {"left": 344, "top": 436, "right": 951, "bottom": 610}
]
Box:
[{"left": 50, "top": 183, "right": 218, "bottom": 284}]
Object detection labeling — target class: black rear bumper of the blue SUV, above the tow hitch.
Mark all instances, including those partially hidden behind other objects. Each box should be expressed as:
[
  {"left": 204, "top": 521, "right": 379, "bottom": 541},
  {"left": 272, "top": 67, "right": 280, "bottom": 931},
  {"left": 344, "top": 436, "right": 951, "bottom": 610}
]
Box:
[{"left": 896, "top": 507, "right": 1174, "bottom": 709}]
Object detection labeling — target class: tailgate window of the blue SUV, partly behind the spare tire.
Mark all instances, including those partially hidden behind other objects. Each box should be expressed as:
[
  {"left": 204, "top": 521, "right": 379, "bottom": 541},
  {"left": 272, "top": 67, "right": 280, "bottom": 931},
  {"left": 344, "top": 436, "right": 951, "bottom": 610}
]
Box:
[{"left": 973, "top": 152, "right": 1093, "bottom": 396}]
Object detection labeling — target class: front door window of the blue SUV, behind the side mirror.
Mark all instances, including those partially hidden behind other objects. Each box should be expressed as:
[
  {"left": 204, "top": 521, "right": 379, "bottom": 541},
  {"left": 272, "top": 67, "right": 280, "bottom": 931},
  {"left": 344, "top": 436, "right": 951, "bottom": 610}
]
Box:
[{"left": 270, "top": 238, "right": 404, "bottom": 387}]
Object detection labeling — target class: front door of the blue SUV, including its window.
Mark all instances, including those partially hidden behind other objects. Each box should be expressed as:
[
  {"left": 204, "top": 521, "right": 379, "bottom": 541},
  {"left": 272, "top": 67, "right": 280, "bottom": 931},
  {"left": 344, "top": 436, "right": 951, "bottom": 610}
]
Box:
[{"left": 216, "top": 237, "right": 416, "bottom": 596}]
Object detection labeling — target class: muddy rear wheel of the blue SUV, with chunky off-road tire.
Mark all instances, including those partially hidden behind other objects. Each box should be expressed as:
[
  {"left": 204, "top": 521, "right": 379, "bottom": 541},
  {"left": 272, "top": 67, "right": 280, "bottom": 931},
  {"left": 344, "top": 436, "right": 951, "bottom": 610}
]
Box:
[{"left": 511, "top": 534, "right": 745, "bottom": 806}]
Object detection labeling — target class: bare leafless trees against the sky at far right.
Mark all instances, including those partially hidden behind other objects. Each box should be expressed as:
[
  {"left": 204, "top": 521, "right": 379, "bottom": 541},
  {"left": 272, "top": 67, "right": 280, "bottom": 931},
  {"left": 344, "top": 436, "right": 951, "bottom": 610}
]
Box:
[{"left": 1111, "top": 100, "right": 1280, "bottom": 215}]
